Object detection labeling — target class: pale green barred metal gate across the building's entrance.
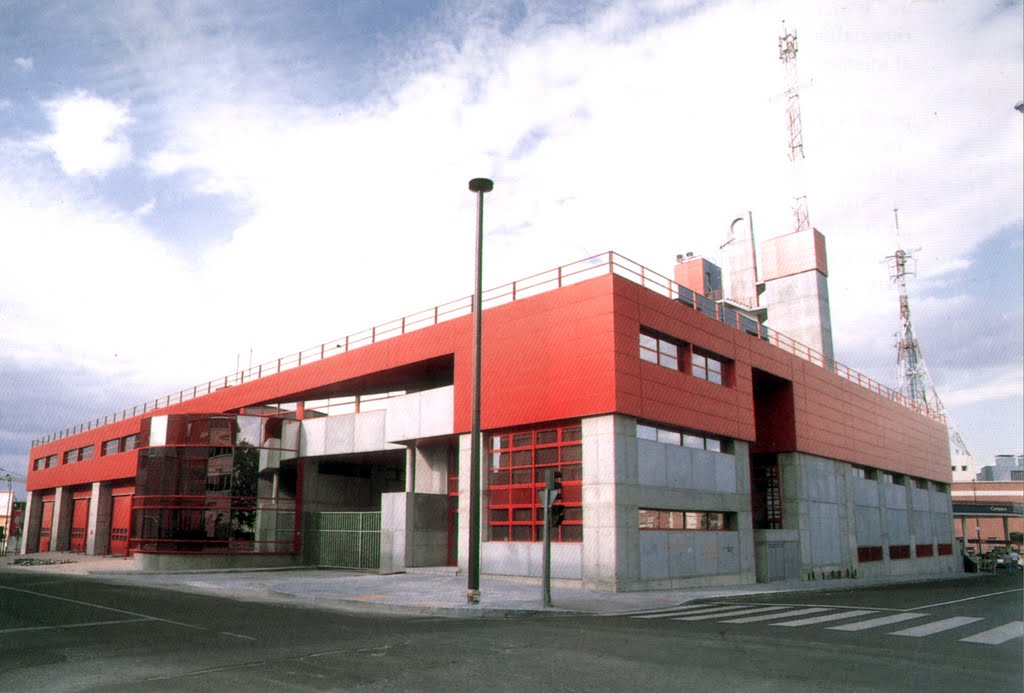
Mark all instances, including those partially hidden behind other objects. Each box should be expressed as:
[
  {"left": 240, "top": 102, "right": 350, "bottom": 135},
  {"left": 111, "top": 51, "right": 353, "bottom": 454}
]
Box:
[{"left": 306, "top": 512, "right": 381, "bottom": 570}]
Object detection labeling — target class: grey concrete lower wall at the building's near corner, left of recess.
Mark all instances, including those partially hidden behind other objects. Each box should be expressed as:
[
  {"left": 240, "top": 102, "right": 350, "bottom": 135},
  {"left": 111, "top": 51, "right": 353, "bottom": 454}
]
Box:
[{"left": 583, "top": 415, "right": 755, "bottom": 591}]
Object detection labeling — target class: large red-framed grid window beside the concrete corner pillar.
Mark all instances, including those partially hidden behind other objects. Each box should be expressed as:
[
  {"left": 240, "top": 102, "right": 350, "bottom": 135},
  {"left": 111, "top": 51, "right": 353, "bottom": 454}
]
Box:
[{"left": 487, "top": 422, "right": 583, "bottom": 542}]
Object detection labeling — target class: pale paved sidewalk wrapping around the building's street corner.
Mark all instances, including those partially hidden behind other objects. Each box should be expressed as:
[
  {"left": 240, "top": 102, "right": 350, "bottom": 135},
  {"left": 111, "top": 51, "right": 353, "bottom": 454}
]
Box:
[{"left": 0, "top": 553, "right": 984, "bottom": 617}]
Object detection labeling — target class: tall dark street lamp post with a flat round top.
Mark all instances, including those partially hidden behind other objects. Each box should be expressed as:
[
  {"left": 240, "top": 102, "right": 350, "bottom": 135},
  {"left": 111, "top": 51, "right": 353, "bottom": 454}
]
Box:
[{"left": 466, "top": 178, "right": 495, "bottom": 604}]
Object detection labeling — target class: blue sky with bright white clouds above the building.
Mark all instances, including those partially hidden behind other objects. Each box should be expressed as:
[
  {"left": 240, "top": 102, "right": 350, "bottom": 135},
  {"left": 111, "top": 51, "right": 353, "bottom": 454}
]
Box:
[{"left": 0, "top": 0, "right": 1024, "bottom": 489}]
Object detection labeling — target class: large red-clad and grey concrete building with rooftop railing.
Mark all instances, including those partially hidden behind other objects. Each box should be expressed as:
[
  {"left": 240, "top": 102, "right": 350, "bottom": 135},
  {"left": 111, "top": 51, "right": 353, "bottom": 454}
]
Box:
[{"left": 23, "top": 248, "right": 961, "bottom": 591}]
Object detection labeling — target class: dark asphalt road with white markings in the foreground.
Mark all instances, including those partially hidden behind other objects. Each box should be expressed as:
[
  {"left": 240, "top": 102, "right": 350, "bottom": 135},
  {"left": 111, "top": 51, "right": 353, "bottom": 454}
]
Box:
[{"left": 0, "top": 571, "right": 1024, "bottom": 693}]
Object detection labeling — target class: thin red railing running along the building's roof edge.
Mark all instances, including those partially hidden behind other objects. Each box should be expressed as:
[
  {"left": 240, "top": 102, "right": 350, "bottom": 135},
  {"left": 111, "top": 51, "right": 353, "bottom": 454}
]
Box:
[{"left": 32, "top": 252, "right": 945, "bottom": 447}]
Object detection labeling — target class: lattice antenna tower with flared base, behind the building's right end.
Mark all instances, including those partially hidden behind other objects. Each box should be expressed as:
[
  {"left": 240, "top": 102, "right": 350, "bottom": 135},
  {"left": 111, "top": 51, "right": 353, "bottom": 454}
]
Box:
[{"left": 886, "top": 209, "right": 970, "bottom": 454}]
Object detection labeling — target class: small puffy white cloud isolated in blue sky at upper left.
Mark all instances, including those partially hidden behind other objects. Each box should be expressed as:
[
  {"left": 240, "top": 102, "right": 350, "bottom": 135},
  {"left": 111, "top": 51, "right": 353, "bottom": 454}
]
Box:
[{"left": 40, "top": 89, "right": 133, "bottom": 176}]
